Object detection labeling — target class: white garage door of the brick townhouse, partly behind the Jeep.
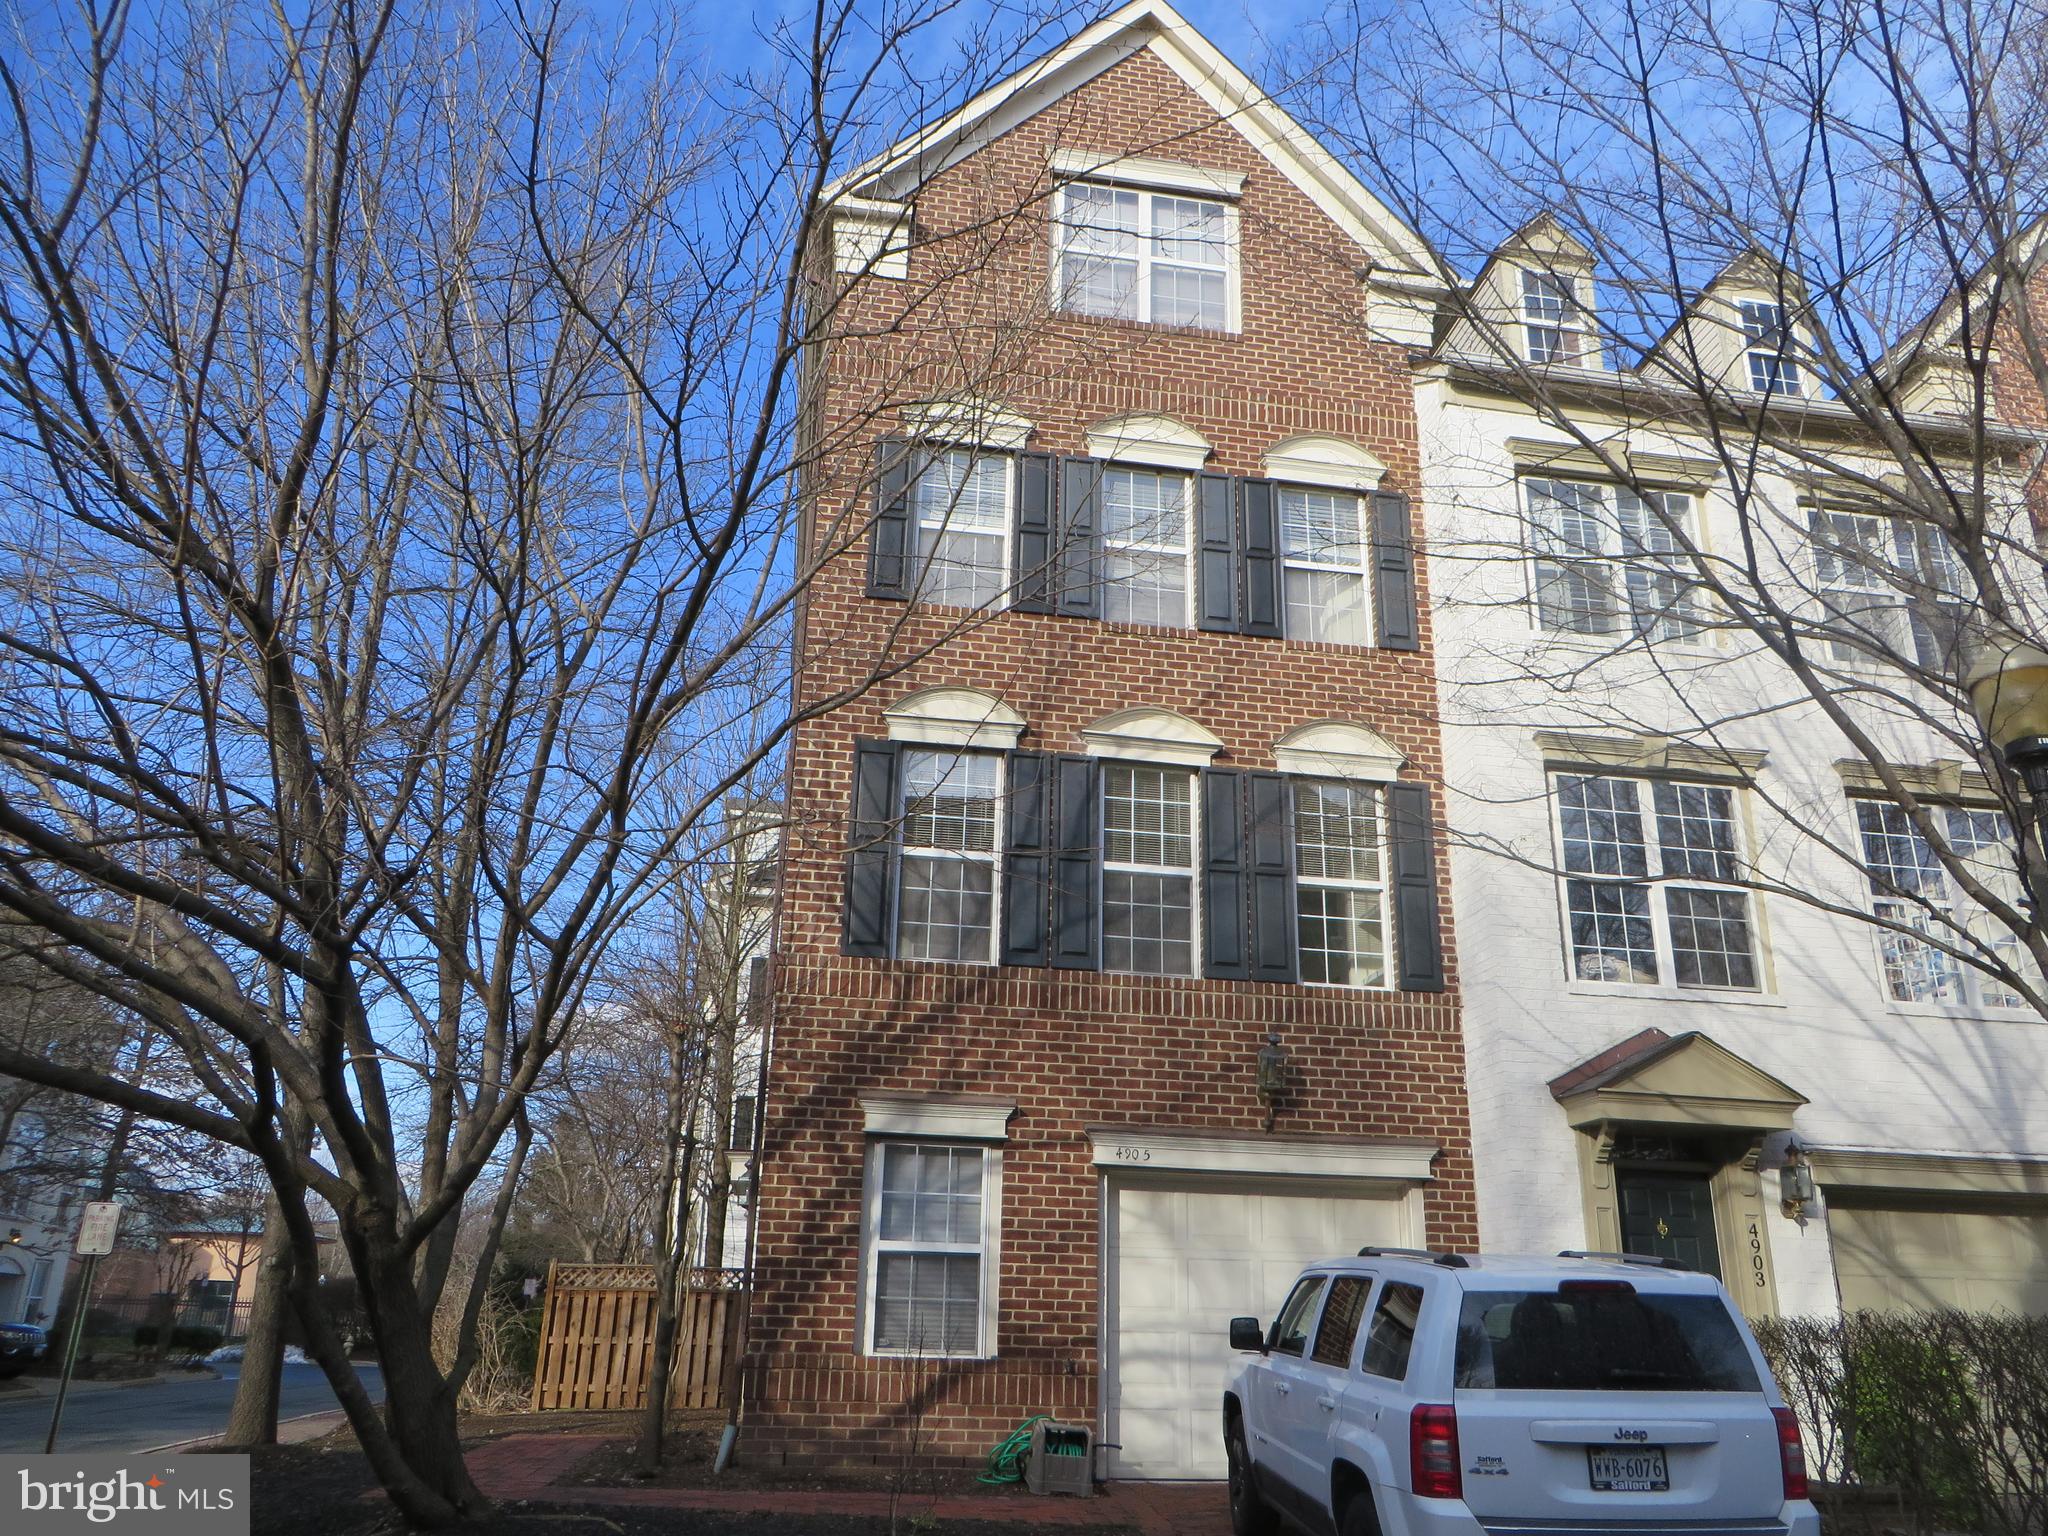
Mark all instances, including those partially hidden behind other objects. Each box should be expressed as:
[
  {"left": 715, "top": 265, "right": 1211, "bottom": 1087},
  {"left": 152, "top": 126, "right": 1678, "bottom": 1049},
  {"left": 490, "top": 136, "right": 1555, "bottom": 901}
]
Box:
[{"left": 1104, "top": 1178, "right": 1411, "bottom": 1477}]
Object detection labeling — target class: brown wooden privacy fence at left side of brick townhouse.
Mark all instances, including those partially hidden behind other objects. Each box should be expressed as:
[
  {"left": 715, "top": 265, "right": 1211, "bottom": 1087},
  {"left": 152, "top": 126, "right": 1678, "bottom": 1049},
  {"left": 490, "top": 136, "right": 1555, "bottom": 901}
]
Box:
[{"left": 532, "top": 1264, "right": 745, "bottom": 1413}]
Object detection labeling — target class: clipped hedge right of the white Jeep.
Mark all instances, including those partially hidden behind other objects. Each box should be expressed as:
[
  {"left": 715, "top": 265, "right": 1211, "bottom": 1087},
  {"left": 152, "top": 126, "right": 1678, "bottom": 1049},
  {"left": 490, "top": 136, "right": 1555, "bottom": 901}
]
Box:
[{"left": 1757, "top": 1311, "right": 2048, "bottom": 1536}]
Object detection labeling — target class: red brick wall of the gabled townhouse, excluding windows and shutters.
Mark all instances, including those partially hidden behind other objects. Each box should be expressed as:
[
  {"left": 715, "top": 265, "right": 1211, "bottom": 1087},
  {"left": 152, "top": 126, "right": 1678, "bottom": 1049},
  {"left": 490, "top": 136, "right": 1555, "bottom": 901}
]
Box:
[{"left": 748, "top": 53, "right": 1477, "bottom": 1458}]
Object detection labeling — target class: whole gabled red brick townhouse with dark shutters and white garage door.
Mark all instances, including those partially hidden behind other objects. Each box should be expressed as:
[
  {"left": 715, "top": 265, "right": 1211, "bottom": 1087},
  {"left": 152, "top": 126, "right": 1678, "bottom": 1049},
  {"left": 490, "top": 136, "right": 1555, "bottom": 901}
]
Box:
[{"left": 745, "top": 0, "right": 1479, "bottom": 1477}]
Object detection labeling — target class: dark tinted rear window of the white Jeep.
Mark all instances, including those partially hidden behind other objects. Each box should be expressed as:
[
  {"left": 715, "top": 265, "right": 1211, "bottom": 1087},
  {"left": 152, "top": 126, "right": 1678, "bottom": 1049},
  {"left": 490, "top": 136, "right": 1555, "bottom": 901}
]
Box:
[{"left": 1456, "top": 1286, "right": 1759, "bottom": 1393}]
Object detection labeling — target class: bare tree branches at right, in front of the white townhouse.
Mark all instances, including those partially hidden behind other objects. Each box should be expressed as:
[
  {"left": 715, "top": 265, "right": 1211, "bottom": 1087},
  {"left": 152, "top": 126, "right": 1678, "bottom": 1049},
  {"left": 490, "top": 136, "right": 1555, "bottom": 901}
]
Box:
[{"left": 1298, "top": 0, "right": 2048, "bottom": 1012}]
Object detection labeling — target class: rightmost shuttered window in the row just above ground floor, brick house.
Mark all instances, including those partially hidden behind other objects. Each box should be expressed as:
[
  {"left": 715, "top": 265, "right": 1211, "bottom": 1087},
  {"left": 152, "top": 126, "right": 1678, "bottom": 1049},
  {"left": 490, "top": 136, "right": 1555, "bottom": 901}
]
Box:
[{"left": 1292, "top": 778, "right": 1386, "bottom": 987}]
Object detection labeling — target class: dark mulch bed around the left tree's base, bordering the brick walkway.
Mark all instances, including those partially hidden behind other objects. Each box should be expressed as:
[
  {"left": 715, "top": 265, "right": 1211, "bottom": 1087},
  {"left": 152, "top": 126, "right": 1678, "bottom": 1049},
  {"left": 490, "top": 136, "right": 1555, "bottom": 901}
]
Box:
[{"left": 250, "top": 1413, "right": 1128, "bottom": 1536}]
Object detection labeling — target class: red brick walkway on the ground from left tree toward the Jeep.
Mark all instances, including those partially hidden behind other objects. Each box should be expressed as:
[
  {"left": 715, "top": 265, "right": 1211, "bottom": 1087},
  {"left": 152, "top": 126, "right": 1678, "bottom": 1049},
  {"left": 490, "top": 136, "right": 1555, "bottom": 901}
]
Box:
[{"left": 469, "top": 1434, "right": 1231, "bottom": 1536}]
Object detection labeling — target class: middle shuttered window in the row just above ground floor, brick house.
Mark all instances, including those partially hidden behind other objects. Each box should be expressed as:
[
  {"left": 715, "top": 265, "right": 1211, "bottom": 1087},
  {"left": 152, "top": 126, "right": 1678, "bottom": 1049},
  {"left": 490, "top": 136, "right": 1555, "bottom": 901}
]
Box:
[{"left": 1102, "top": 764, "right": 1194, "bottom": 977}]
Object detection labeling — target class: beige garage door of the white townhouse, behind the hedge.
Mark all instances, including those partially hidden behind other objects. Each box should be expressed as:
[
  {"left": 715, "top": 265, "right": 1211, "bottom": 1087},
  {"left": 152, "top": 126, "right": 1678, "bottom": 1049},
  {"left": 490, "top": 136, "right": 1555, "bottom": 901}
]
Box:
[{"left": 1827, "top": 1204, "right": 2048, "bottom": 1315}]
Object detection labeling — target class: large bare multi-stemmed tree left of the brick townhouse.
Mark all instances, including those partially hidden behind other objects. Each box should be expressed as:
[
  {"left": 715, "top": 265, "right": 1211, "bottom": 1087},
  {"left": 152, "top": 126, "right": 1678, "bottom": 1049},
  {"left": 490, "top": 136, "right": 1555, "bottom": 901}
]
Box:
[{"left": 0, "top": 0, "right": 1105, "bottom": 1524}]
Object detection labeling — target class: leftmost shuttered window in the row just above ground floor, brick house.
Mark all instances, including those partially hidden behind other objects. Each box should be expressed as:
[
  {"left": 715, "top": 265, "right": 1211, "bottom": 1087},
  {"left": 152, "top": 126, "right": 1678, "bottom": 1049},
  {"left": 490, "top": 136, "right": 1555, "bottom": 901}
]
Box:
[{"left": 897, "top": 752, "right": 1001, "bottom": 961}]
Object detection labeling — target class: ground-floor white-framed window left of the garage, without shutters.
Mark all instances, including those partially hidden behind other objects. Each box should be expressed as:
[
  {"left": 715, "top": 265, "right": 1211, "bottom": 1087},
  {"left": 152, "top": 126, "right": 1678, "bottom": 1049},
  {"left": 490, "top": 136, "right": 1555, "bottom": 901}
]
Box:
[{"left": 866, "top": 1141, "right": 1001, "bottom": 1358}]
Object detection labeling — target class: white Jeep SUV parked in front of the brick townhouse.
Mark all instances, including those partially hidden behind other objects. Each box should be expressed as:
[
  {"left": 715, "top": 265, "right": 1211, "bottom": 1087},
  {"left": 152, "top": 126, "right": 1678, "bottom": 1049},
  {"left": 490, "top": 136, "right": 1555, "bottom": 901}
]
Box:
[{"left": 1223, "top": 1247, "right": 1821, "bottom": 1536}]
